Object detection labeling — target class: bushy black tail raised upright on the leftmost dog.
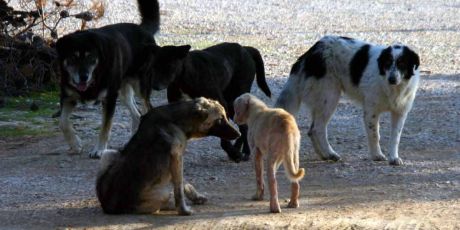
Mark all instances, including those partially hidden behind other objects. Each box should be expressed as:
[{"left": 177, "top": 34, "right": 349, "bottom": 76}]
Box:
[{"left": 137, "top": 0, "right": 160, "bottom": 35}]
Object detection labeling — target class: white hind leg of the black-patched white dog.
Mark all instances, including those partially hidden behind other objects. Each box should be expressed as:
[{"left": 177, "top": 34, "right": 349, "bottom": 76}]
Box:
[{"left": 307, "top": 79, "right": 341, "bottom": 161}]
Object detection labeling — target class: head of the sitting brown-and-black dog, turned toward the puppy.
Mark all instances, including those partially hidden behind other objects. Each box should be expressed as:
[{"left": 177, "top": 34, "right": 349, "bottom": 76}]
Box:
[{"left": 191, "top": 97, "right": 241, "bottom": 140}]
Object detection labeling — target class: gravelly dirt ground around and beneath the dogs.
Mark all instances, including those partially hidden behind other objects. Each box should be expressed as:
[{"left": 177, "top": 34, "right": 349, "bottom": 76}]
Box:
[{"left": 0, "top": 0, "right": 460, "bottom": 229}]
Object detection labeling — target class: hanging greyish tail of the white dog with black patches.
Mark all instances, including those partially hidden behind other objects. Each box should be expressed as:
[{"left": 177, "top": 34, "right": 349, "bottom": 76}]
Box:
[{"left": 275, "top": 59, "right": 307, "bottom": 116}]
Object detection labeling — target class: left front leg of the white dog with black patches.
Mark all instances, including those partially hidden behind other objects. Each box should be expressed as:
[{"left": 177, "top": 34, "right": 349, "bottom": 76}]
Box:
[{"left": 364, "top": 107, "right": 386, "bottom": 161}]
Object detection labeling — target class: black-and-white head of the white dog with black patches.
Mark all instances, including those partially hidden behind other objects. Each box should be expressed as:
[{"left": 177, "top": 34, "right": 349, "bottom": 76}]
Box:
[{"left": 377, "top": 45, "right": 420, "bottom": 85}]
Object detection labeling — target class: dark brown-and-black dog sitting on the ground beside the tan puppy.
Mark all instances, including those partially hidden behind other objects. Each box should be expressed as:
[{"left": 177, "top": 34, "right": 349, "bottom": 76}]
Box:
[{"left": 96, "top": 98, "right": 240, "bottom": 215}]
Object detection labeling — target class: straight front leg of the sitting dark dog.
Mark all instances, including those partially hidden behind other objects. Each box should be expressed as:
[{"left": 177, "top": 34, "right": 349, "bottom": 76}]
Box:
[{"left": 170, "top": 151, "right": 192, "bottom": 215}]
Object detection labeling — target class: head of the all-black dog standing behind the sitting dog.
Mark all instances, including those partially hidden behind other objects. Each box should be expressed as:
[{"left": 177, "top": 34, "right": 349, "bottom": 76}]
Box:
[{"left": 143, "top": 45, "right": 191, "bottom": 90}]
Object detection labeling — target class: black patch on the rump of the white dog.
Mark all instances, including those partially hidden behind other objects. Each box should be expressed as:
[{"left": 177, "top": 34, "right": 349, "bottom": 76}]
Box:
[{"left": 291, "top": 42, "right": 326, "bottom": 79}]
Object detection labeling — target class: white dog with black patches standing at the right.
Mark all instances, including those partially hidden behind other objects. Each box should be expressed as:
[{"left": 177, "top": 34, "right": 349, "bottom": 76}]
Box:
[{"left": 276, "top": 36, "right": 420, "bottom": 165}]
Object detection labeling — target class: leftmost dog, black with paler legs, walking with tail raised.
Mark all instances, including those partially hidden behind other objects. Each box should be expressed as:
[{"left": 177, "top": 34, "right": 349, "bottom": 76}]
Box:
[{"left": 56, "top": 0, "right": 168, "bottom": 158}]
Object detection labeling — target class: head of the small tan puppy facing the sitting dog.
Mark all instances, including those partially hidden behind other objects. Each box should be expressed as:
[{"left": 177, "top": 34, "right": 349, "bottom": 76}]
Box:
[{"left": 233, "top": 93, "right": 265, "bottom": 125}]
